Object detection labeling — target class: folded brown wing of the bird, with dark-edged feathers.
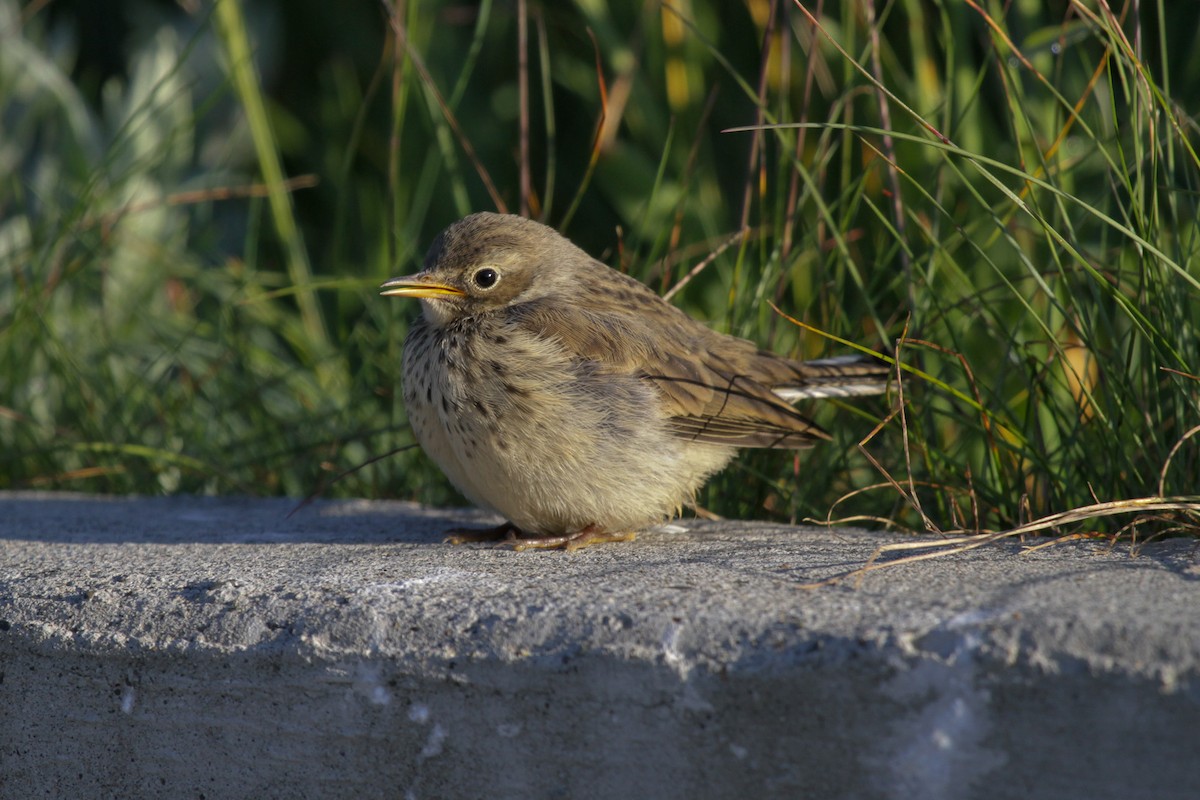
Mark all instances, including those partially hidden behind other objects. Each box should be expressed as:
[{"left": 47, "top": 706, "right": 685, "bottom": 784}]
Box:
[{"left": 510, "top": 280, "right": 829, "bottom": 447}]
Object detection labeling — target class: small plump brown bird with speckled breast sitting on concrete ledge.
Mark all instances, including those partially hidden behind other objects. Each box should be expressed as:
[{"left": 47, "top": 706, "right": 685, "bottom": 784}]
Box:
[{"left": 380, "top": 212, "right": 890, "bottom": 551}]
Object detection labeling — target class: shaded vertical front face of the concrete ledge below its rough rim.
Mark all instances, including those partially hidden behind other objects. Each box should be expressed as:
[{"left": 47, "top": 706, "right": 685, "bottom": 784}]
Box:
[{"left": 9, "top": 599, "right": 1200, "bottom": 800}]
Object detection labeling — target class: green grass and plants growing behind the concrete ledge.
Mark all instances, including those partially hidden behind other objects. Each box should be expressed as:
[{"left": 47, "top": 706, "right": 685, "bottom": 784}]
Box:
[{"left": 0, "top": 0, "right": 1200, "bottom": 530}]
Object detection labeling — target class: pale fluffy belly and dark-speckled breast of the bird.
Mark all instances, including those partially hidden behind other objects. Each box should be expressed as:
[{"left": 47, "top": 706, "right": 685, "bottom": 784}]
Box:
[{"left": 404, "top": 316, "right": 733, "bottom": 534}]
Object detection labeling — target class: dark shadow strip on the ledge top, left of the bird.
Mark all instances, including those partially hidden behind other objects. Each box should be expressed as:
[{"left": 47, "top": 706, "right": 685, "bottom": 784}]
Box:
[{"left": 0, "top": 492, "right": 499, "bottom": 545}]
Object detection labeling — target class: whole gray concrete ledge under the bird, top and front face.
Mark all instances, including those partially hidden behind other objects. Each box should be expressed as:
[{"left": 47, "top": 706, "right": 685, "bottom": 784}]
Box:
[{"left": 0, "top": 493, "right": 1200, "bottom": 800}]
